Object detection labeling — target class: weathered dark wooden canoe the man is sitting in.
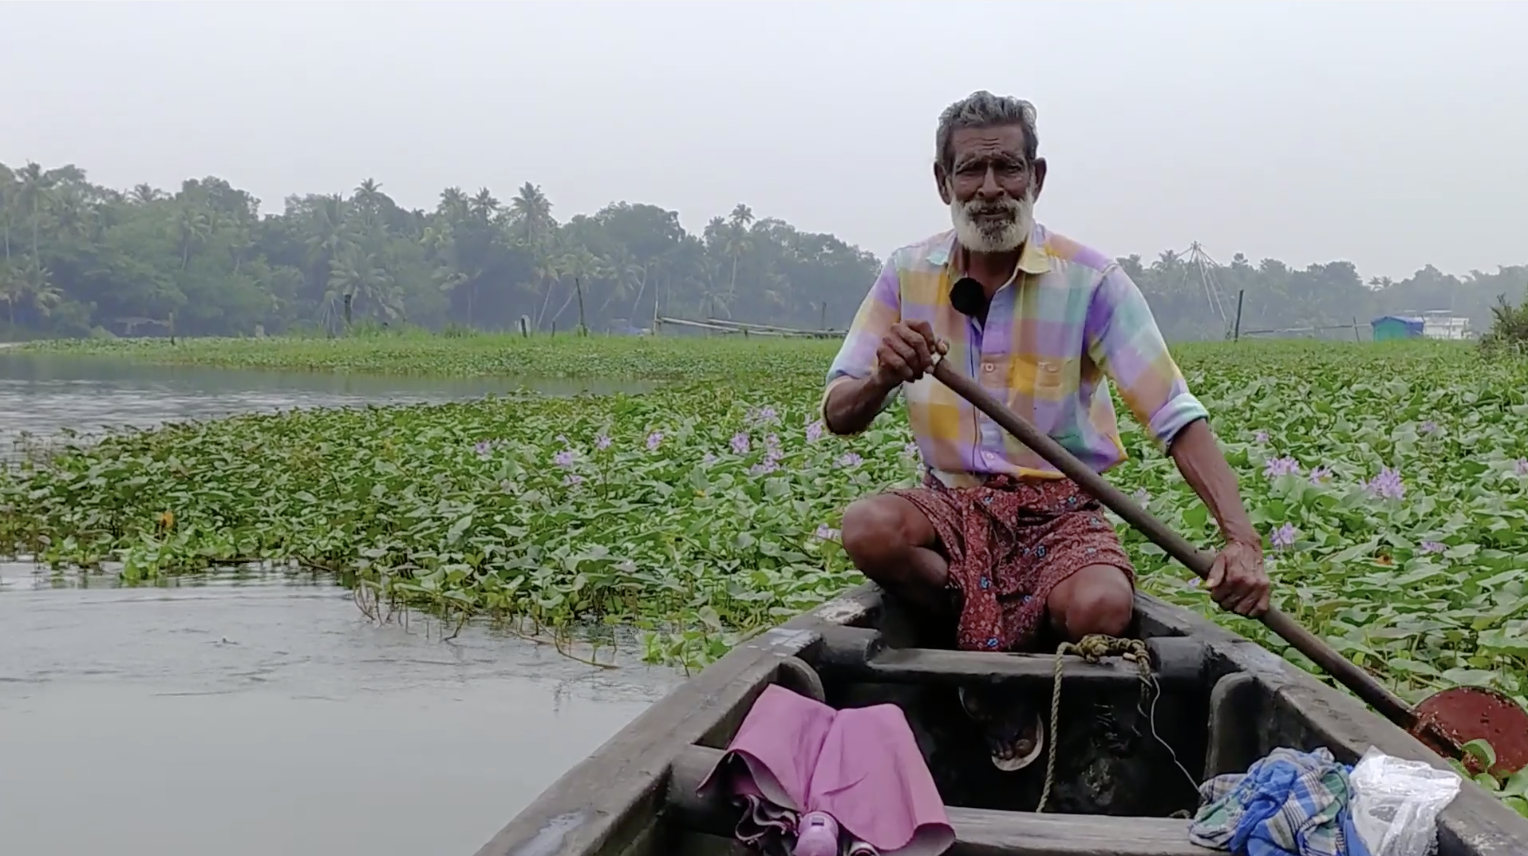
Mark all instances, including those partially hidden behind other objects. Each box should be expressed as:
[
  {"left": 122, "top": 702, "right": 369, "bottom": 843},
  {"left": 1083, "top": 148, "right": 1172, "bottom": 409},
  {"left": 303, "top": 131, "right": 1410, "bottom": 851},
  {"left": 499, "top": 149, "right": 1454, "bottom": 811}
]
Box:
[{"left": 477, "top": 584, "right": 1528, "bottom": 856}]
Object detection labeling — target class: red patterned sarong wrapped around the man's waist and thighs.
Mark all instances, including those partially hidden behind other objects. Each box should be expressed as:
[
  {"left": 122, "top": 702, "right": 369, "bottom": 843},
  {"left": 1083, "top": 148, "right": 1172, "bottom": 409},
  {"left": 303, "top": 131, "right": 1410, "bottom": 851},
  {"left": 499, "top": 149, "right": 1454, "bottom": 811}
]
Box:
[{"left": 892, "top": 474, "right": 1135, "bottom": 651}]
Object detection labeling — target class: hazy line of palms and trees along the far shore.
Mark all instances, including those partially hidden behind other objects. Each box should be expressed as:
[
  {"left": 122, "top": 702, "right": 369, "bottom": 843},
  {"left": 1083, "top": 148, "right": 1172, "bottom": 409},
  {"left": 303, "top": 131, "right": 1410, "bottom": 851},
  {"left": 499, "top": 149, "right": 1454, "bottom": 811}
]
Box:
[{"left": 0, "top": 162, "right": 1528, "bottom": 341}]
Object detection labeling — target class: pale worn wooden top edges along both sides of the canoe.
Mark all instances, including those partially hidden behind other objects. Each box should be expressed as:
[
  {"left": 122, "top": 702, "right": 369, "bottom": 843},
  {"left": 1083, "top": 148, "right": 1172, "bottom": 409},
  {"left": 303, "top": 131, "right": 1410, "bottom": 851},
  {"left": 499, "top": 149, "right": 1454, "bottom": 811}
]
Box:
[{"left": 475, "top": 582, "right": 1528, "bottom": 856}]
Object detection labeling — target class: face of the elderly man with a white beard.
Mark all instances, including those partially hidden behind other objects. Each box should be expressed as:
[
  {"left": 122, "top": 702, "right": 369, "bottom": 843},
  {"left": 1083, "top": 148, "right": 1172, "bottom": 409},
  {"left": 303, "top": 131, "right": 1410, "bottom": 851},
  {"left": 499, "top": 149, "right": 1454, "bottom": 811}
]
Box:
[{"left": 934, "top": 125, "right": 1045, "bottom": 252}]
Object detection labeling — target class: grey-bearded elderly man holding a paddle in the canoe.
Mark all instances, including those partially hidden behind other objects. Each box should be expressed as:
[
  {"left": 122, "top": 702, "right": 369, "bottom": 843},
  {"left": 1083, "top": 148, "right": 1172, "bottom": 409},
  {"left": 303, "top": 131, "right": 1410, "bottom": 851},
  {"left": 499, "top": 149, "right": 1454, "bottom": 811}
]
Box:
[{"left": 822, "top": 92, "right": 1268, "bottom": 769}]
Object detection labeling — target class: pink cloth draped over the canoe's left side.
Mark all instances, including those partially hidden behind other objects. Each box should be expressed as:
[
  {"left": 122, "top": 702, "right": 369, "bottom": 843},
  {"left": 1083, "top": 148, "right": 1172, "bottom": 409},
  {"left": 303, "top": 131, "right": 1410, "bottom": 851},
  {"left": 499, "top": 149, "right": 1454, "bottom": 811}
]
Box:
[{"left": 700, "top": 685, "right": 955, "bottom": 856}]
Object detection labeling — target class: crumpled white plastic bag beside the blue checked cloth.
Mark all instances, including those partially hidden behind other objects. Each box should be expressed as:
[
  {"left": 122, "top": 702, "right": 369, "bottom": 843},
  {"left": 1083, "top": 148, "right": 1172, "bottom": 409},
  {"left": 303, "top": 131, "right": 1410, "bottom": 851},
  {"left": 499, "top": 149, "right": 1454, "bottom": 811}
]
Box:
[{"left": 1348, "top": 746, "right": 1461, "bottom": 856}]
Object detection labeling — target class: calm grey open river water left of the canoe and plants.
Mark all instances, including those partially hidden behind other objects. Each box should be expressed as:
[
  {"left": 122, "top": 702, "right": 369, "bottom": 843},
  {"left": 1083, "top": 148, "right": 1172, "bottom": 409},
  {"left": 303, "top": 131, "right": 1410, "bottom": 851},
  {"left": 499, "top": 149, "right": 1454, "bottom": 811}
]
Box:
[{"left": 0, "top": 353, "right": 681, "bottom": 856}]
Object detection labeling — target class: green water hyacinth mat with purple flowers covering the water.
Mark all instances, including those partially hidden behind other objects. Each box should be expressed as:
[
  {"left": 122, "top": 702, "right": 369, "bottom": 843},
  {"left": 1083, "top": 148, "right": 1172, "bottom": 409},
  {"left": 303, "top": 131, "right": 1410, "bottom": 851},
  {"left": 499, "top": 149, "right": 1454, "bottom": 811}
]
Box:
[{"left": 0, "top": 336, "right": 1528, "bottom": 697}]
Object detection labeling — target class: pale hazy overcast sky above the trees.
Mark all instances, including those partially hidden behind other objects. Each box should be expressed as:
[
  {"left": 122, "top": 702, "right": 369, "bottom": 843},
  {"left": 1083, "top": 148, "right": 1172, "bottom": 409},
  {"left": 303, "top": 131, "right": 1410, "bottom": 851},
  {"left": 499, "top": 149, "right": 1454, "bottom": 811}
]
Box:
[{"left": 0, "top": 0, "right": 1528, "bottom": 277}]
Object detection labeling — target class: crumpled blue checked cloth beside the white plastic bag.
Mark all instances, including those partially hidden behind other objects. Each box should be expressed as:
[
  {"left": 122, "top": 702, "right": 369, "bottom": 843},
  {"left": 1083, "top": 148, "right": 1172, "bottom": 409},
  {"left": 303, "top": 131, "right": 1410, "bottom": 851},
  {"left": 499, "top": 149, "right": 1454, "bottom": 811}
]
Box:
[{"left": 1189, "top": 747, "right": 1368, "bottom": 856}]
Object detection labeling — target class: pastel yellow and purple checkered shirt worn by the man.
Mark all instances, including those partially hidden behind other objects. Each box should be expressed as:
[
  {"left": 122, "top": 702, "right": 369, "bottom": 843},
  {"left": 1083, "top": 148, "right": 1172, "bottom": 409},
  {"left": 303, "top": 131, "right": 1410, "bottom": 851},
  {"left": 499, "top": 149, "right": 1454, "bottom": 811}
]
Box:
[{"left": 822, "top": 225, "right": 1207, "bottom": 486}]
